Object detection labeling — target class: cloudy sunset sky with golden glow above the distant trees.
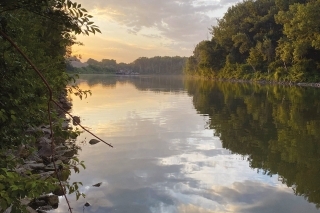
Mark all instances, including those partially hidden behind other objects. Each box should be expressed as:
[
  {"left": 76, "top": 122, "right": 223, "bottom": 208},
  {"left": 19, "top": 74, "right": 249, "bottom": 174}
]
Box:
[{"left": 72, "top": 0, "right": 239, "bottom": 63}]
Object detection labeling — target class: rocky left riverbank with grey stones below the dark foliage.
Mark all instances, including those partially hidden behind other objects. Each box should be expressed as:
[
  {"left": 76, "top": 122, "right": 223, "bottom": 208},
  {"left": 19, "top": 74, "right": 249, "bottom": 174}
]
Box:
[{"left": 0, "top": 94, "right": 80, "bottom": 213}]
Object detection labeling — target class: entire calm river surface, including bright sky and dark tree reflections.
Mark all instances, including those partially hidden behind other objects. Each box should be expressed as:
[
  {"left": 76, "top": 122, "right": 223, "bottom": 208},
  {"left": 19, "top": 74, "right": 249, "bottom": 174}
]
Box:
[{"left": 55, "top": 75, "right": 320, "bottom": 213}]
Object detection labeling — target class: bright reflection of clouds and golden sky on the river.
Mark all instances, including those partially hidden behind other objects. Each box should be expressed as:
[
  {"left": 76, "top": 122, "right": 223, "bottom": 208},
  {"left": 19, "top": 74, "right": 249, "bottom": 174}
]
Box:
[{"left": 56, "top": 78, "right": 319, "bottom": 213}]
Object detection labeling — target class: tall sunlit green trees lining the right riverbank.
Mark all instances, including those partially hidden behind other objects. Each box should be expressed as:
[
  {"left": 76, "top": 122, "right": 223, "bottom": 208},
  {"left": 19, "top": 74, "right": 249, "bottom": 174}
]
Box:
[{"left": 184, "top": 0, "right": 320, "bottom": 82}]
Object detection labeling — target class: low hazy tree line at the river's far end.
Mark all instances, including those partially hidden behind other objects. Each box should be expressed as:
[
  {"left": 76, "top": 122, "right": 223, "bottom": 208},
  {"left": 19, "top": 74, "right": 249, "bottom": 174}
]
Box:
[{"left": 68, "top": 56, "right": 187, "bottom": 75}]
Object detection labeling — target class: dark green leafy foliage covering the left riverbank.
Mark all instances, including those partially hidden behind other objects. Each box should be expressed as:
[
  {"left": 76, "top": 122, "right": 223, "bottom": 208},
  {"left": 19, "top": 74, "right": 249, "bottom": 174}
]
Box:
[{"left": 0, "top": 0, "right": 100, "bottom": 212}]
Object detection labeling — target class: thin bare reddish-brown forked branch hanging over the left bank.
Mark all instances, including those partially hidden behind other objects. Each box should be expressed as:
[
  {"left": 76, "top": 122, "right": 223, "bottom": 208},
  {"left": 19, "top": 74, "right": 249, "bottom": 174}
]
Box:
[{"left": 0, "top": 30, "right": 113, "bottom": 213}]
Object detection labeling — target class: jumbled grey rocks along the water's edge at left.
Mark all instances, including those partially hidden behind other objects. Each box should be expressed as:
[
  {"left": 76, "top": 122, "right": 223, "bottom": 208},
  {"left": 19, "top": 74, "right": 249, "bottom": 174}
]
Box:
[{"left": 10, "top": 95, "right": 80, "bottom": 213}]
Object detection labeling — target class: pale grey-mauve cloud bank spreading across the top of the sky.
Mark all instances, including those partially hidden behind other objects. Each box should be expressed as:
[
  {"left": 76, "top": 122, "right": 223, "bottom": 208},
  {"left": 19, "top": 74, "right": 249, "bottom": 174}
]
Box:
[{"left": 75, "top": 0, "right": 230, "bottom": 42}]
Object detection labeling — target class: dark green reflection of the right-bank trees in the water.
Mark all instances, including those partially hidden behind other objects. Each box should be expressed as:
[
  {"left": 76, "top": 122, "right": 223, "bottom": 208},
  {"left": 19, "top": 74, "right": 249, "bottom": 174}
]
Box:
[{"left": 186, "top": 80, "right": 320, "bottom": 207}]
